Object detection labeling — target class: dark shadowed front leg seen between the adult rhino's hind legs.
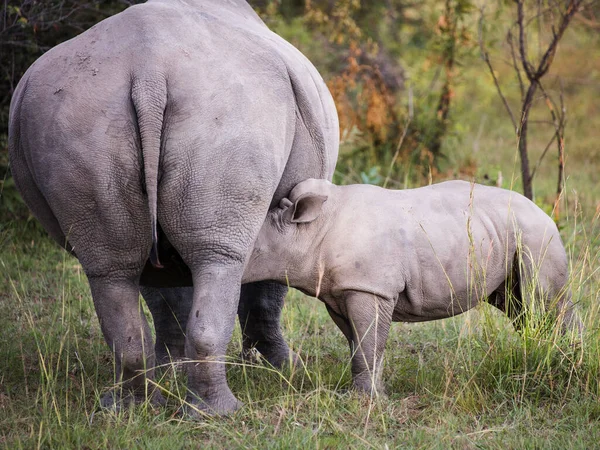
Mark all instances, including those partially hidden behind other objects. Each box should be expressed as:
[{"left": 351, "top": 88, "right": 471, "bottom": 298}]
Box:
[{"left": 140, "top": 286, "right": 194, "bottom": 365}]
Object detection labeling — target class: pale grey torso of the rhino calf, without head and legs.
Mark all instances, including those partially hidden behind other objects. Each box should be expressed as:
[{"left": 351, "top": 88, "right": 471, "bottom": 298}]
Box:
[{"left": 323, "top": 181, "right": 564, "bottom": 320}]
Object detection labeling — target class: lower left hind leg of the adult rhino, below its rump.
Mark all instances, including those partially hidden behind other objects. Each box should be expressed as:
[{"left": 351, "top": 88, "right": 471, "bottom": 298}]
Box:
[{"left": 89, "top": 277, "right": 164, "bottom": 409}]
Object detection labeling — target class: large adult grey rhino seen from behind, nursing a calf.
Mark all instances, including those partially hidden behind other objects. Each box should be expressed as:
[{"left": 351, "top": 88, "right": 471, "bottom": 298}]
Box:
[{"left": 9, "top": 0, "right": 339, "bottom": 413}]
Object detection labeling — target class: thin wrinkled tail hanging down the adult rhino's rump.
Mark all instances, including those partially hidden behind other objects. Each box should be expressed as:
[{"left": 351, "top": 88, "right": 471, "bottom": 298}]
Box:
[{"left": 131, "top": 76, "right": 167, "bottom": 268}]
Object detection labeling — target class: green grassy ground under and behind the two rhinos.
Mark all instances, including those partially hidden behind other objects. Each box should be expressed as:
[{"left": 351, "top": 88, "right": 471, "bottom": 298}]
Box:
[{"left": 0, "top": 6, "right": 600, "bottom": 449}]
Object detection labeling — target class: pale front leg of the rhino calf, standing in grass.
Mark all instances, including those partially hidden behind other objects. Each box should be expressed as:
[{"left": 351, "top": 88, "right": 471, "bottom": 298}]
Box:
[{"left": 342, "top": 292, "right": 393, "bottom": 396}]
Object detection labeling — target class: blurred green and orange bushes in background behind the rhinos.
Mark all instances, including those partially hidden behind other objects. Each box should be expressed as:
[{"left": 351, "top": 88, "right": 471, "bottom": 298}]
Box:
[{"left": 0, "top": 0, "right": 600, "bottom": 221}]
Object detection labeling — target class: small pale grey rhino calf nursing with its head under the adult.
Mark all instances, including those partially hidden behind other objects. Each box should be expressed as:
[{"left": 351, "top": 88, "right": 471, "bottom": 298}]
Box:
[{"left": 244, "top": 180, "right": 581, "bottom": 393}]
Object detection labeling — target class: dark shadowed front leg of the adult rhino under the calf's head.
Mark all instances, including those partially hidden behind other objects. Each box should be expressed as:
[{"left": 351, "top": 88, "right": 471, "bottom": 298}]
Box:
[{"left": 238, "top": 281, "right": 297, "bottom": 368}]
